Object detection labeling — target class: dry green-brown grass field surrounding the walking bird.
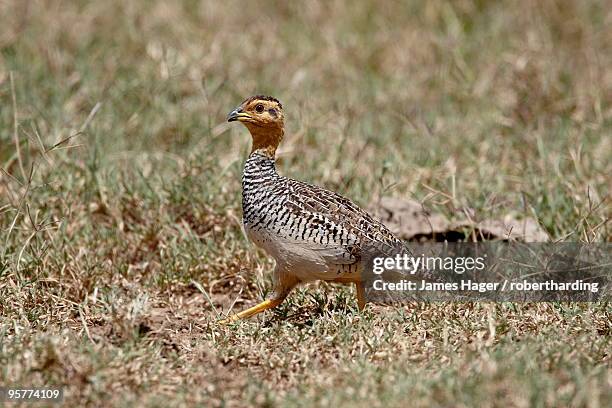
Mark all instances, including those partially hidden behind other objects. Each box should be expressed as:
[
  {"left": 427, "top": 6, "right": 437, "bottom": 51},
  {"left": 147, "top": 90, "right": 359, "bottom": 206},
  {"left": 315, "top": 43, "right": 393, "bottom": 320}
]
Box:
[{"left": 0, "top": 0, "right": 612, "bottom": 407}]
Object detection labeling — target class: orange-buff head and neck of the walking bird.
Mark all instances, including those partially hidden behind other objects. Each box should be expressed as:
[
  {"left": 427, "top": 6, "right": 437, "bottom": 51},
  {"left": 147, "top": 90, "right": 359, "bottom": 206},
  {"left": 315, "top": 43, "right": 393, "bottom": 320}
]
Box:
[{"left": 227, "top": 95, "right": 285, "bottom": 158}]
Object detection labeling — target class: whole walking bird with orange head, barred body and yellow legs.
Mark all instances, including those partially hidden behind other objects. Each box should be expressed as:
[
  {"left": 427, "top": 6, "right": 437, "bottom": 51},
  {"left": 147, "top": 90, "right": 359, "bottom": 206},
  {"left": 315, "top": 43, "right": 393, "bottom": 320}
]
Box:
[{"left": 221, "top": 95, "right": 403, "bottom": 324}]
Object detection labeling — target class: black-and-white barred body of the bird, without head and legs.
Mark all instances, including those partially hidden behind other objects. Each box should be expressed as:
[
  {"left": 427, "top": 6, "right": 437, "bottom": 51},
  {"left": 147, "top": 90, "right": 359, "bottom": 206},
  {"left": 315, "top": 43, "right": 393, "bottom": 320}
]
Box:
[{"left": 242, "top": 152, "right": 401, "bottom": 282}]
